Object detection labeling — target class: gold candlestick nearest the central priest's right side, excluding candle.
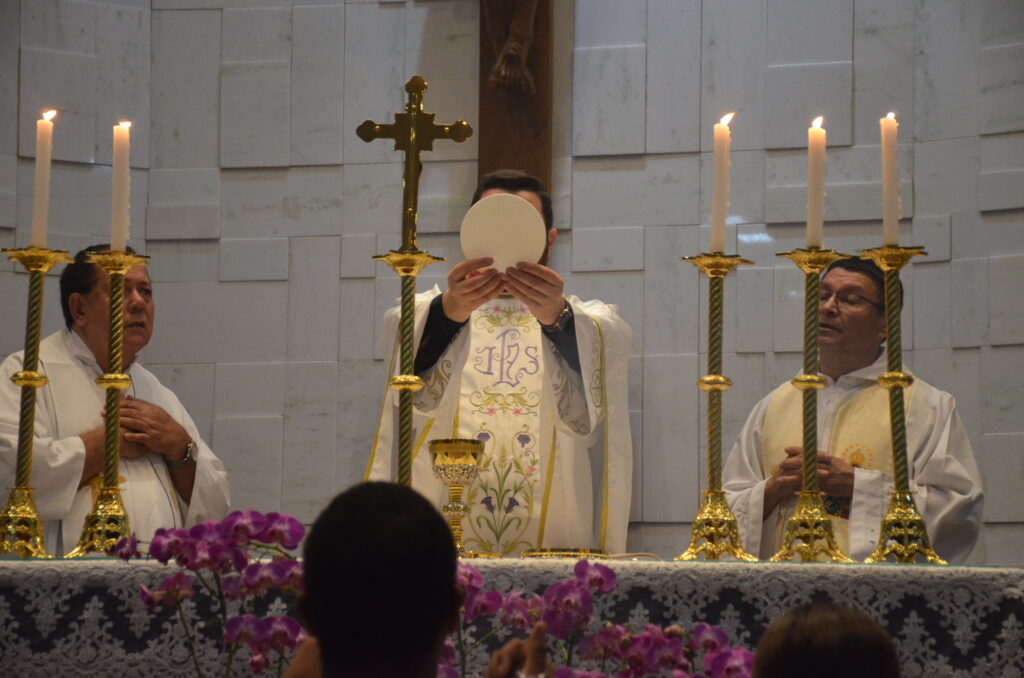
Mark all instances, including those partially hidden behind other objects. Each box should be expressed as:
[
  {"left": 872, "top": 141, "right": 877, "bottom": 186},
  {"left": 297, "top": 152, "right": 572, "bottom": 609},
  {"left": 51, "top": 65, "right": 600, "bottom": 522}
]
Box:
[{"left": 676, "top": 252, "right": 757, "bottom": 561}]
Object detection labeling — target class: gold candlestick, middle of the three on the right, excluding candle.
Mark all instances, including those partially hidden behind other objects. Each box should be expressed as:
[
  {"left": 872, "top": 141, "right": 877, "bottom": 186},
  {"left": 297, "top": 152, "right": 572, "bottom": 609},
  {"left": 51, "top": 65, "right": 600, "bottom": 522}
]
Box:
[{"left": 771, "top": 247, "right": 853, "bottom": 562}]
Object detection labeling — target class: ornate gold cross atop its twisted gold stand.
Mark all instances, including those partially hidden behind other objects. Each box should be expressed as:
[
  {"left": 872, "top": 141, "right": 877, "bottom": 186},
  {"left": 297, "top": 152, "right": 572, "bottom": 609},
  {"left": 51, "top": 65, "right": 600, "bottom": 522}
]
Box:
[{"left": 355, "top": 76, "right": 473, "bottom": 485}]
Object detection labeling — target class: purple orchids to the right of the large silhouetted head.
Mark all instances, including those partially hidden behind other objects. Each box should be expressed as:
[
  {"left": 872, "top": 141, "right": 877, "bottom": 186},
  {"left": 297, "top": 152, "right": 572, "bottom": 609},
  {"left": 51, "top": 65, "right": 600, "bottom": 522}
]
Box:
[{"left": 437, "top": 560, "right": 754, "bottom": 678}]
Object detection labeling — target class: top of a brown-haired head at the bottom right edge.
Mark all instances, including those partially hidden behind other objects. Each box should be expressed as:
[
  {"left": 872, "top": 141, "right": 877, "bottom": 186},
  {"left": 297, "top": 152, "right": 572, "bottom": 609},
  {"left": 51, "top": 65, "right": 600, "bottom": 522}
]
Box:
[{"left": 753, "top": 602, "right": 899, "bottom": 678}]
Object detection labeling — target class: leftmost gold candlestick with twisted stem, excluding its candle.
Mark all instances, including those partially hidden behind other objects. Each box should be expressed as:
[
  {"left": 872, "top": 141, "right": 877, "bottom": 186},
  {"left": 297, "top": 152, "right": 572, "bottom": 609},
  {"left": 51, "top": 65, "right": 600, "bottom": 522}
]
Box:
[{"left": 0, "top": 247, "right": 71, "bottom": 558}]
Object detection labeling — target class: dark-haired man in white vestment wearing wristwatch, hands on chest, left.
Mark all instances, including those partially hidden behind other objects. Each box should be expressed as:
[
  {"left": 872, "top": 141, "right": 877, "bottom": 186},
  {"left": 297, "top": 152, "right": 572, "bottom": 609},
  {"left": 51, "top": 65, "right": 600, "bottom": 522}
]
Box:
[{"left": 0, "top": 246, "right": 228, "bottom": 555}]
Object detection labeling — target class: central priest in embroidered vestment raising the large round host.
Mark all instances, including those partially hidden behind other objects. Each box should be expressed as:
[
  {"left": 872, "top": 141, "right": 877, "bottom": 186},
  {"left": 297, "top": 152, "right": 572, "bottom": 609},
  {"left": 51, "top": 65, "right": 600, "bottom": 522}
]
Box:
[{"left": 367, "top": 170, "right": 633, "bottom": 555}]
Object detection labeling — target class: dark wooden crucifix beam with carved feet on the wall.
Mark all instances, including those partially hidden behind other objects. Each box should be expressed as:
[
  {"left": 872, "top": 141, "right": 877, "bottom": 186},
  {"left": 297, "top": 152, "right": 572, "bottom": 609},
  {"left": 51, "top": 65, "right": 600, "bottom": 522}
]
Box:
[{"left": 477, "top": 0, "right": 554, "bottom": 189}]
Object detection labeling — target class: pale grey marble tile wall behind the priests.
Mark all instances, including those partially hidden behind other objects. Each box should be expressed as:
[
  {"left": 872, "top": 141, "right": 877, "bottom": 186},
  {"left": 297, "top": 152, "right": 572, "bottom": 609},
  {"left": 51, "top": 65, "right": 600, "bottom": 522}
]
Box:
[{"left": 0, "top": 0, "right": 1024, "bottom": 564}]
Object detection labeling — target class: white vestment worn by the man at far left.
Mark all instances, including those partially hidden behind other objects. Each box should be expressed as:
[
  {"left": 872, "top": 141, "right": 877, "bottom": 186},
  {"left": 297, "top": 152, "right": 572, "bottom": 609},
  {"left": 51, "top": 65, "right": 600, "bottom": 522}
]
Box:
[{"left": 0, "top": 330, "right": 228, "bottom": 556}]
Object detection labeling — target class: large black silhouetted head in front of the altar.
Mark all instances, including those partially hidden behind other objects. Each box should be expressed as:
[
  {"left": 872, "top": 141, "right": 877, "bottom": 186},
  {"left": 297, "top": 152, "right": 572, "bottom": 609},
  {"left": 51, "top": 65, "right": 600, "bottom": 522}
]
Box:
[{"left": 302, "top": 482, "right": 457, "bottom": 676}]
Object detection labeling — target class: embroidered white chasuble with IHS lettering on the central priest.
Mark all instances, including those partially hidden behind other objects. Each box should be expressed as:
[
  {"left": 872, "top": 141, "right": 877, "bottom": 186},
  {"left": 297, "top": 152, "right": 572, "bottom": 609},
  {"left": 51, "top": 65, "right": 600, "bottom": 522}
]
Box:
[{"left": 367, "top": 288, "right": 632, "bottom": 555}]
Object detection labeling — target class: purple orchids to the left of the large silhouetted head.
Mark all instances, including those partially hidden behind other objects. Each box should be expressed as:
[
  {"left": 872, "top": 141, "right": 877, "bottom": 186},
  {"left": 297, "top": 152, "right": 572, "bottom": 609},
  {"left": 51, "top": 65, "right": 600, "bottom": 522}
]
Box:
[{"left": 117, "top": 511, "right": 306, "bottom": 678}]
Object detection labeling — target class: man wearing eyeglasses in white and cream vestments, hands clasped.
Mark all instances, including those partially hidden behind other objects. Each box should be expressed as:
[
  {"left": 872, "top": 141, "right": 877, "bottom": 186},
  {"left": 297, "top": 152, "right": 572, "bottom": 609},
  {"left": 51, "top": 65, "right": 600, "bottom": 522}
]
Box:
[{"left": 723, "top": 258, "right": 982, "bottom": 562}]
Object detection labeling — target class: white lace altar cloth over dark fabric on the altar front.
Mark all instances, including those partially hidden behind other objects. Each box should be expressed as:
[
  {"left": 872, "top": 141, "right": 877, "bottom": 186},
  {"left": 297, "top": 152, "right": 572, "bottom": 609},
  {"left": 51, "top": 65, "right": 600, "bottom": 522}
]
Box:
[{"left": 0, "top": 559, "right": 1024, "bottom": 678}]
